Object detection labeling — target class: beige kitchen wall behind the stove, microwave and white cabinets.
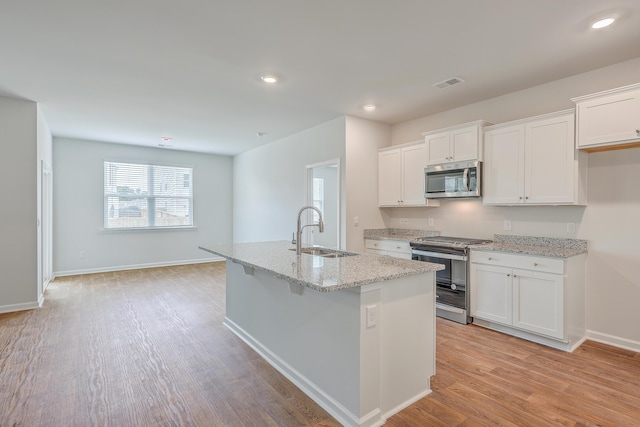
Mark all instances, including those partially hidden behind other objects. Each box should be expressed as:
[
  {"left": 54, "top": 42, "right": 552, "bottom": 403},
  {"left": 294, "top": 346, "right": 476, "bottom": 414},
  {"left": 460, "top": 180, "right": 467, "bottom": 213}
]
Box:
[{"left": 383, "top": 58, "right": 640, "bottom": 350}]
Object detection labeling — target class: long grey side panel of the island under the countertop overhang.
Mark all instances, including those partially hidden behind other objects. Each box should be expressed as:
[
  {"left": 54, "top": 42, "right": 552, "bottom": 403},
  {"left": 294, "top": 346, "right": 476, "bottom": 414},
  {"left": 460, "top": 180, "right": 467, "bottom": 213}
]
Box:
[{"left": 225, "top": 262, "right": 364, "bottom": 425}]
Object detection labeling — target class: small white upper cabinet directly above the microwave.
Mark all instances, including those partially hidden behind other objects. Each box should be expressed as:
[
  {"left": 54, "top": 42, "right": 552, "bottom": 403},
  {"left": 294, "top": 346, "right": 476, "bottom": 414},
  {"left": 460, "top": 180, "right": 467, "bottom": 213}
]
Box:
[{"left": 422, "top": 120, "right": 490, "bottom": 165}]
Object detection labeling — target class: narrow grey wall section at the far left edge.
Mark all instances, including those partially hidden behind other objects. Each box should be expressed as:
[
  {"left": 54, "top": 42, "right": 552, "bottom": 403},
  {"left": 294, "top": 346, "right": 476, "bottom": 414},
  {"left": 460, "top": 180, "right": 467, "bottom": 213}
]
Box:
[{"left": 0, "top": 97, "right": 38, "bottom": 312}]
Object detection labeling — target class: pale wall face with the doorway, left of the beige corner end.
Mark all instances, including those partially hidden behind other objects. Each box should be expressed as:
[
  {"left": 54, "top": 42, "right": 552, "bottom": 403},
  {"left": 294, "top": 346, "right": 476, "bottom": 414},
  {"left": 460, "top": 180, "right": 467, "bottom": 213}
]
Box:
[{"left": 233, "top": 117, "right": 345, "bottom": 247}]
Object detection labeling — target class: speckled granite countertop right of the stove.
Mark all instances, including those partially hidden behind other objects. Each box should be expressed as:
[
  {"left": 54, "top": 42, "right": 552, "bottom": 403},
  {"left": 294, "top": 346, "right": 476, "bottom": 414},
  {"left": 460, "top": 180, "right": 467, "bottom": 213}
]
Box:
[{"left": 471, "top": 234, "right": 588, "bottom": 258}]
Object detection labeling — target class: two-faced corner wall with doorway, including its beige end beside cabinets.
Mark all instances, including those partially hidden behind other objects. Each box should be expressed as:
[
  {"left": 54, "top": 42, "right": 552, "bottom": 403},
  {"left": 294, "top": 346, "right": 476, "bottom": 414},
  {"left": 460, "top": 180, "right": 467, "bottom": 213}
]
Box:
[{"left": 234, "top": 116, "right": 391, "bottom": 252}]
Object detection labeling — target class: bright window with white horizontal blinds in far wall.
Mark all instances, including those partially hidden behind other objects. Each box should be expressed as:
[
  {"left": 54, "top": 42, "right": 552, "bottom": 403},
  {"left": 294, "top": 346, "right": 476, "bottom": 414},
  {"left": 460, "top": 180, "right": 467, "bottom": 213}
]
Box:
[{"left": 104, "top": 161, "right": 193, "bottom": 229}]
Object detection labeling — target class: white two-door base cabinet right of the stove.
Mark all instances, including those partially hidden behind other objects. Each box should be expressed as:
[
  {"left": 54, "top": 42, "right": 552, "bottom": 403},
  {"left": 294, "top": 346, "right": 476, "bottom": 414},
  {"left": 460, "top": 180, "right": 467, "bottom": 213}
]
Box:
[{"left": 470, "top": 251, "right": 585, "bottom": 351}]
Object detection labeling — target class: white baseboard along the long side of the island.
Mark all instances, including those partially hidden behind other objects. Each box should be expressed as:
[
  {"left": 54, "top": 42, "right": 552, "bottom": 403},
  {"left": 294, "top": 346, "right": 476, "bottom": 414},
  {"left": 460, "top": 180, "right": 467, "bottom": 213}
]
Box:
[{"left": 223, "top": 317, "right": 384, "bottom": 427}]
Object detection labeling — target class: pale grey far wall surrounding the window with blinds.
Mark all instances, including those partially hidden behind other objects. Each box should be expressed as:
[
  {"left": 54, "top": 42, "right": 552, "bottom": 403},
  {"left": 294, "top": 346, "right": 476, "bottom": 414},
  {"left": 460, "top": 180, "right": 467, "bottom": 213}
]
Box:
[{"left": 53, "top": 138, "right": 233, "bottom": 275}]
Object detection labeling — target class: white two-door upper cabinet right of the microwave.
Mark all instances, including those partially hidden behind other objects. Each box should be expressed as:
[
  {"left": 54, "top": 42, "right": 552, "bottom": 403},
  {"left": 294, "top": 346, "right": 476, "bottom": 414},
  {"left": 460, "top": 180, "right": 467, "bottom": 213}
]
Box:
[{"left": 483, "top": 110, "right": 587, "bottom": 205}]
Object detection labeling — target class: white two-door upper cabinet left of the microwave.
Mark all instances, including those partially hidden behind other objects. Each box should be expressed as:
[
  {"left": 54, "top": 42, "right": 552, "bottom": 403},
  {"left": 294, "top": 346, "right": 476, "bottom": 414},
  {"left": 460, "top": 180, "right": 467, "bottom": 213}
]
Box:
[{"left": 378, "top": 141, "right": 440, "bottom": 206}]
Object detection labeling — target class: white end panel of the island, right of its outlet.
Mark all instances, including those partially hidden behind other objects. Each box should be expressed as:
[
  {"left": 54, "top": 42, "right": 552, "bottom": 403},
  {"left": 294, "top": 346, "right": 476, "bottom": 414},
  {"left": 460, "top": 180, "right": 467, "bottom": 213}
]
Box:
[{"left": 380, "top": 272, "right": 436, "bottom": 419}]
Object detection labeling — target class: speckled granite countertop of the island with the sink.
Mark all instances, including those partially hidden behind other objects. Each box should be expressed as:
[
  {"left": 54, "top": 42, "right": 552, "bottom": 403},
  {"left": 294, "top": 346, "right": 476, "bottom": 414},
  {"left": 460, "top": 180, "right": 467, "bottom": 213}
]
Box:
[{"left": 200, "top": 241, "right": 444, "bottom": 292}]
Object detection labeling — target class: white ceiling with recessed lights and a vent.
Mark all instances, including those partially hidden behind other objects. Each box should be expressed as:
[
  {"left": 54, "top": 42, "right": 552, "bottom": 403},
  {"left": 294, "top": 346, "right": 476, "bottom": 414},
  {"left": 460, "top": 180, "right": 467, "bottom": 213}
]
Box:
[{"left": 0, "top": 0, "right": 640, "bottom": 154}]
